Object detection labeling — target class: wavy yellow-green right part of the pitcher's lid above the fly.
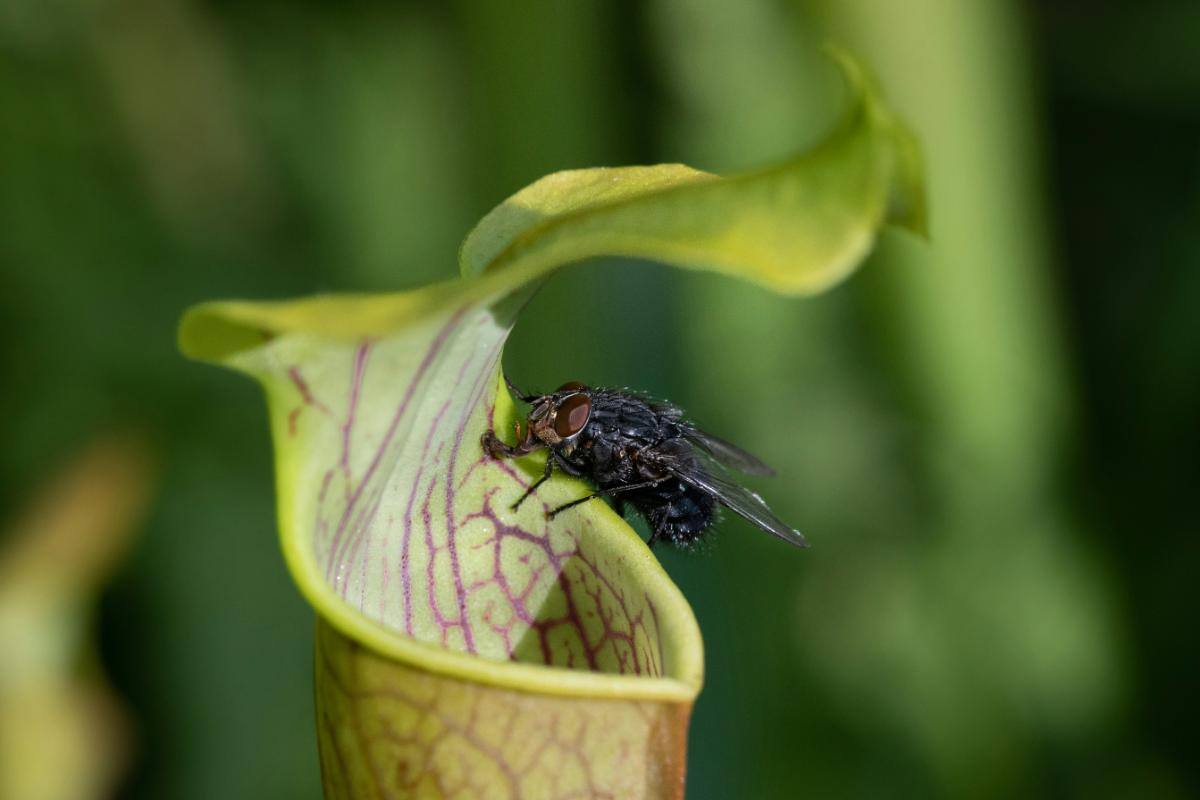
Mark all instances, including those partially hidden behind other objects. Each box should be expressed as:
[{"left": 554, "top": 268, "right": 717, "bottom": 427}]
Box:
[{"left": 458, "top": 49, "right": 925, "bottom": 294}]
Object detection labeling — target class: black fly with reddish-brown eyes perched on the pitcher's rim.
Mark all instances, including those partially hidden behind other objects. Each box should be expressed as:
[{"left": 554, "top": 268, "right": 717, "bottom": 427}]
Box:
[{"left": 482, "top": 383, "right": 808, "bottom": 547}]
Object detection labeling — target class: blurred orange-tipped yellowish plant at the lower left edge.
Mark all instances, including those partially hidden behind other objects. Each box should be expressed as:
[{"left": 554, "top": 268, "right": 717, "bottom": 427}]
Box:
[{"left": 0, "top": 438, "right": 150, "bottom": 800}]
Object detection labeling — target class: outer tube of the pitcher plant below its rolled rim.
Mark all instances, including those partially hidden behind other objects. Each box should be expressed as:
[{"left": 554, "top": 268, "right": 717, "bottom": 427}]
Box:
[{"left": 316, "top": 625, "right": 690, "bottom": 800}]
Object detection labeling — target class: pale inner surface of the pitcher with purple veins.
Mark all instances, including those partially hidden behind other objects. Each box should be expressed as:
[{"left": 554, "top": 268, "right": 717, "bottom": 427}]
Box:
[{"left": 276, "top": 307, "right": 665, "bottom": 675}]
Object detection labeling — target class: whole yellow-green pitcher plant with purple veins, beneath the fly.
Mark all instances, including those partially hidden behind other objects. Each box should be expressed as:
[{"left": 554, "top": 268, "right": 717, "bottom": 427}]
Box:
[{"left": 180, "top": 55, "right": 922, "bottom": 798}]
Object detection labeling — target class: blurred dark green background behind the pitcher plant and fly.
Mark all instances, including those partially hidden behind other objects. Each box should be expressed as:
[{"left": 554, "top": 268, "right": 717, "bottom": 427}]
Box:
[{"left": 0, "top": 0, "right": 1200, "bottom": 799}]
